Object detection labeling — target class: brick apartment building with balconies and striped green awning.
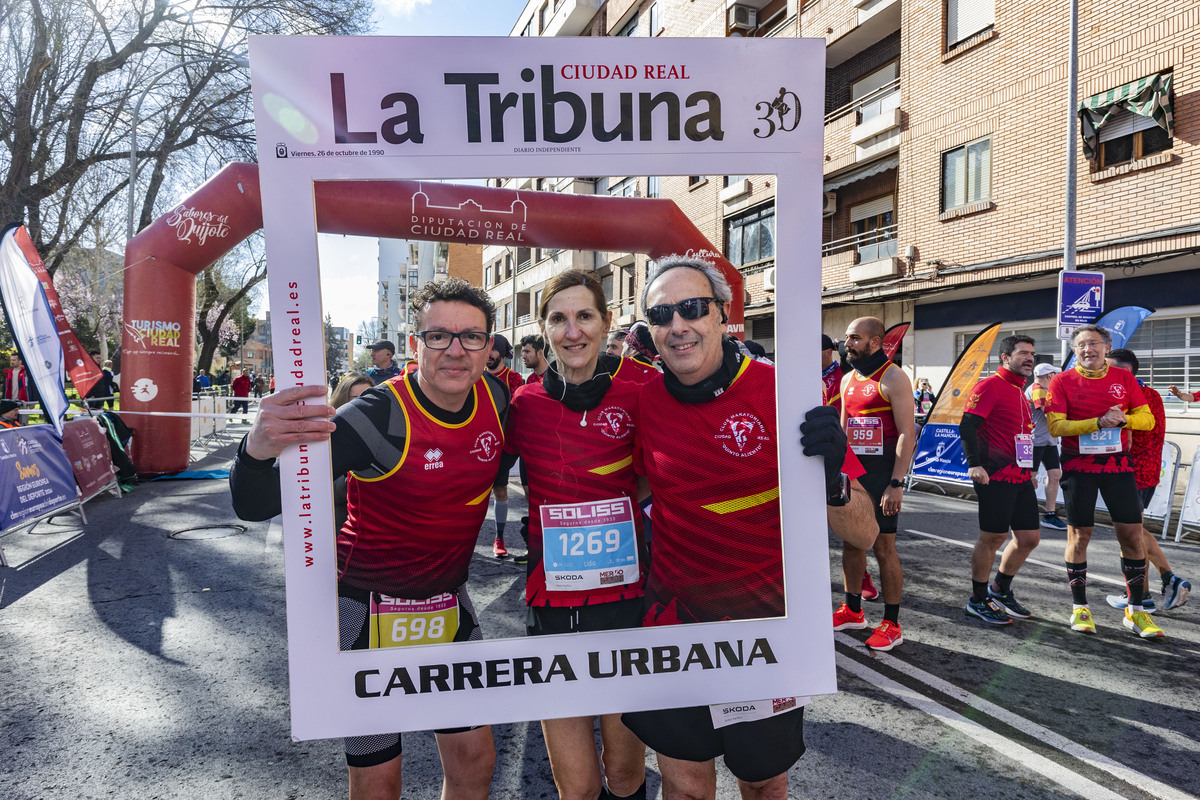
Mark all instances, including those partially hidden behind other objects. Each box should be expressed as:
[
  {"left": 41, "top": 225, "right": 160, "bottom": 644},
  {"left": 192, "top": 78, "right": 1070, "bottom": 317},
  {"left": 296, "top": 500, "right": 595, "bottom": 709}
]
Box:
[{"left": 504, "top": 0, "right": 1200, "bottom": 438}]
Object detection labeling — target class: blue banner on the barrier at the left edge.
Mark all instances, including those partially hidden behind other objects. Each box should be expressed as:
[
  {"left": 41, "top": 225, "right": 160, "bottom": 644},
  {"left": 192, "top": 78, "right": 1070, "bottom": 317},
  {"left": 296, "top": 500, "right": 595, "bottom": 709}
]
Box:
[{"left": 0, "top": 425, "right": 78, "bottom": 530}]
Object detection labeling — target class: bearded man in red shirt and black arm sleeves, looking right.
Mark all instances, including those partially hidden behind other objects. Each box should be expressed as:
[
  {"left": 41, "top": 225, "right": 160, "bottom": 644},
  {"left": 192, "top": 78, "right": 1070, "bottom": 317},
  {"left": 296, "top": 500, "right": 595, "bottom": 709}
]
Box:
[{"left": 959, "top": 336, "right": 1040, "bottom": 625}]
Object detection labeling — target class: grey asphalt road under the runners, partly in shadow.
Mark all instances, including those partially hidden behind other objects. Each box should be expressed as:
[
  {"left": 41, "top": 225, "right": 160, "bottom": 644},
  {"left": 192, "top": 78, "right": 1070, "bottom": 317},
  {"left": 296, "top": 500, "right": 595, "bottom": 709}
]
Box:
[{"left": 0, "top": 431, "right": 1200, "bottom": 800}]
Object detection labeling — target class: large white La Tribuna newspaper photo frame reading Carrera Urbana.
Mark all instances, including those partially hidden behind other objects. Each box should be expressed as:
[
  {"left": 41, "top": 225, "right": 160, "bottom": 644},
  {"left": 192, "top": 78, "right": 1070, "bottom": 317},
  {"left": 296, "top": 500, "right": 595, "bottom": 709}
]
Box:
[{"left": 250, "top": 37, "right": 836, "bottom": 739}]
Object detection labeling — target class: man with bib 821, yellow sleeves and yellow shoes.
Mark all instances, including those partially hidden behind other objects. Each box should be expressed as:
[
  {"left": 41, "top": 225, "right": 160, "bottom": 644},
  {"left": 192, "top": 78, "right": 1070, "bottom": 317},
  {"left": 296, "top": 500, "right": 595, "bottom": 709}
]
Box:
[{"left": 1045, "top": 325, "right": 1163, "bottom": 639}]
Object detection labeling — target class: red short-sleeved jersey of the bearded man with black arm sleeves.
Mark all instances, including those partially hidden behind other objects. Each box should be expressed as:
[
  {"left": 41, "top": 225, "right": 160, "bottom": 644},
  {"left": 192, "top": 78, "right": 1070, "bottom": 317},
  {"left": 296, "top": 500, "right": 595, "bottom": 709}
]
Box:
[{"left": 962, "top": 367, "right": 1033, "bottom": 483}]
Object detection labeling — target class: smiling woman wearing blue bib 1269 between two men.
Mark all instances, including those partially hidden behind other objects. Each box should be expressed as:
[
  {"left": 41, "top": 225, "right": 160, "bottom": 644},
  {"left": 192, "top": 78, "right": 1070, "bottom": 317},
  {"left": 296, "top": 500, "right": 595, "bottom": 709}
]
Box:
[{"left": 502, "top": 270, "right": 647, "bottom": 798}]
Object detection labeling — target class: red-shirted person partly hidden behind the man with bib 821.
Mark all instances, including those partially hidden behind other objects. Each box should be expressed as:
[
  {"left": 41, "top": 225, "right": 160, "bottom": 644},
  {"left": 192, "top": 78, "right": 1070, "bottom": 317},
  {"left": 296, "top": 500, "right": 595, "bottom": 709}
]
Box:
[{"left": 1105, "top": 349, "right": 1192, "bottom": 610}]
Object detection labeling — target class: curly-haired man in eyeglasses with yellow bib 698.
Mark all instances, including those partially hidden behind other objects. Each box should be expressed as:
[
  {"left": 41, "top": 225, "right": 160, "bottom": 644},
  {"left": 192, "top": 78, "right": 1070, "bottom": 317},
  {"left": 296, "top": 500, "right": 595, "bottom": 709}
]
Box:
[{"left": 229, "top": 278, "right": 509, "bottom": 800}]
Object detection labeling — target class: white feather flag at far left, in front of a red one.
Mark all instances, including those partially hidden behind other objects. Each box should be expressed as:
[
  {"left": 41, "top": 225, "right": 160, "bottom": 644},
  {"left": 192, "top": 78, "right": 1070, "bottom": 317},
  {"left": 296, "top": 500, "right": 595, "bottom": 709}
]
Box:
[{"left": 0, "top": 229, "right": 70, "bottom": 434}]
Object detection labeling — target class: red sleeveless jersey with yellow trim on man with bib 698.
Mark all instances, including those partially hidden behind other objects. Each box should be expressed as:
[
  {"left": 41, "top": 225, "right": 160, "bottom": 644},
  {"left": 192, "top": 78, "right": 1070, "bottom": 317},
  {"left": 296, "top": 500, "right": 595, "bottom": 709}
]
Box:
[{"left": 337, "top": 374, "right": 504, "bottom": 600}]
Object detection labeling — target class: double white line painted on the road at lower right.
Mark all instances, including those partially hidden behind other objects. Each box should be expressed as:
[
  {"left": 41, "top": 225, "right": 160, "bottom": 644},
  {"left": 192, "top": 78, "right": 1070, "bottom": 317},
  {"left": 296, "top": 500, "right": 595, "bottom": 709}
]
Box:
[{"left": 834, "top": 633, "right": 1194, "bottom": 800}]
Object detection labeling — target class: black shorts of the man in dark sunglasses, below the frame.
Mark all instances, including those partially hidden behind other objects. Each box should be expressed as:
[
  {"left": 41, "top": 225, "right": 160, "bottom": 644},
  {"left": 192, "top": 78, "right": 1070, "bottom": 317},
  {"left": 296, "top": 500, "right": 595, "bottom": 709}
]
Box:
[{"left": 620, "top": 705, "right": 804, "bottom": 781}]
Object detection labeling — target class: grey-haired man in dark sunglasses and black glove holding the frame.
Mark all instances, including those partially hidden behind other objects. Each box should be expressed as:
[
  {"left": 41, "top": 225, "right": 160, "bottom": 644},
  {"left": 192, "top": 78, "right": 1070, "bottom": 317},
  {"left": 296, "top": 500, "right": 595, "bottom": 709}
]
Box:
[{"left": 623, "top": 255, "right": 876, "bottom": 798}]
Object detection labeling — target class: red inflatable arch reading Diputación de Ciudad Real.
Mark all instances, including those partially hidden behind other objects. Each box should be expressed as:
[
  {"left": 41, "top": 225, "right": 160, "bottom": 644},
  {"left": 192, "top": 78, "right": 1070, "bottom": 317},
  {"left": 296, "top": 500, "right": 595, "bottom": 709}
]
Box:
[{"left": 121, "top": 163, "right": 744, "bottom": 475}]
